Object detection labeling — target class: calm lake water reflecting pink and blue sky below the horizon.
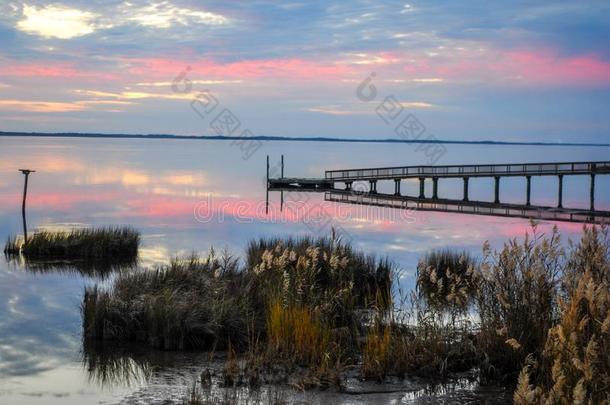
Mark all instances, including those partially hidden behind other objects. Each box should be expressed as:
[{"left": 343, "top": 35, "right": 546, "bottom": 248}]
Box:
[{"left": 0, "top": 138, "right": 610, "bottom": 404}]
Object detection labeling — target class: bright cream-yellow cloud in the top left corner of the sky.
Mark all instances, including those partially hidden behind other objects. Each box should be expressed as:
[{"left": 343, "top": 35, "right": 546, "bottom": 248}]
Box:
[{"left": 17, "top": 4, "right": 96, "bottom": 39}]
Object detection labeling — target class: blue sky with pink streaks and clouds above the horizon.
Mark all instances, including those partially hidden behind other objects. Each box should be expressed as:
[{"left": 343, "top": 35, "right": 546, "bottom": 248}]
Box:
[{"left": 0, "top": 0, "right": 610, "bottom": 142}]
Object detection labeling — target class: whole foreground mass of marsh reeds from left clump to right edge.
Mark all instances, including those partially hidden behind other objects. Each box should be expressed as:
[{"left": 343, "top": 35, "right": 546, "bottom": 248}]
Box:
[{"left": 82, "top": 226, "right": 610, "bottom": 404}]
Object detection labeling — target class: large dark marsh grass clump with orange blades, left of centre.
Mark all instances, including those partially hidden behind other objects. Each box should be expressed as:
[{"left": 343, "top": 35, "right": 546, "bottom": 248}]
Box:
[{"left": 82, "top": 232, "right": 392, "bottom": 367}]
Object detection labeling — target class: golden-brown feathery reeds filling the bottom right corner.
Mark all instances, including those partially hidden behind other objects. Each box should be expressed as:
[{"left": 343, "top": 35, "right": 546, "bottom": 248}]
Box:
[{"left": 514, "top": 228, "right": 610, "bottom": 404}]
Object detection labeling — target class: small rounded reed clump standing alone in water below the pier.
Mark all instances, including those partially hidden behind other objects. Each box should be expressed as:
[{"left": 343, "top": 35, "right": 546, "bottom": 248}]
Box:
[{"left": 416, "top": 249, "right": 479, "bottom": 311}]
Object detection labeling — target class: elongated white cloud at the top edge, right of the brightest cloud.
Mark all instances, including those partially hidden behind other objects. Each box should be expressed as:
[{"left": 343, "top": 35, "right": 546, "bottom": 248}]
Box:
[{"left": 126, "top": 1, "right": 229, "bottom": 28}]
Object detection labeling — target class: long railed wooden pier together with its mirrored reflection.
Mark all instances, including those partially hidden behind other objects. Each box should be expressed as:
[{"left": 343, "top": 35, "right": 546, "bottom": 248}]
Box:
[{"left": 267, "top": 160, "right": 610, "bottom": 223}]
